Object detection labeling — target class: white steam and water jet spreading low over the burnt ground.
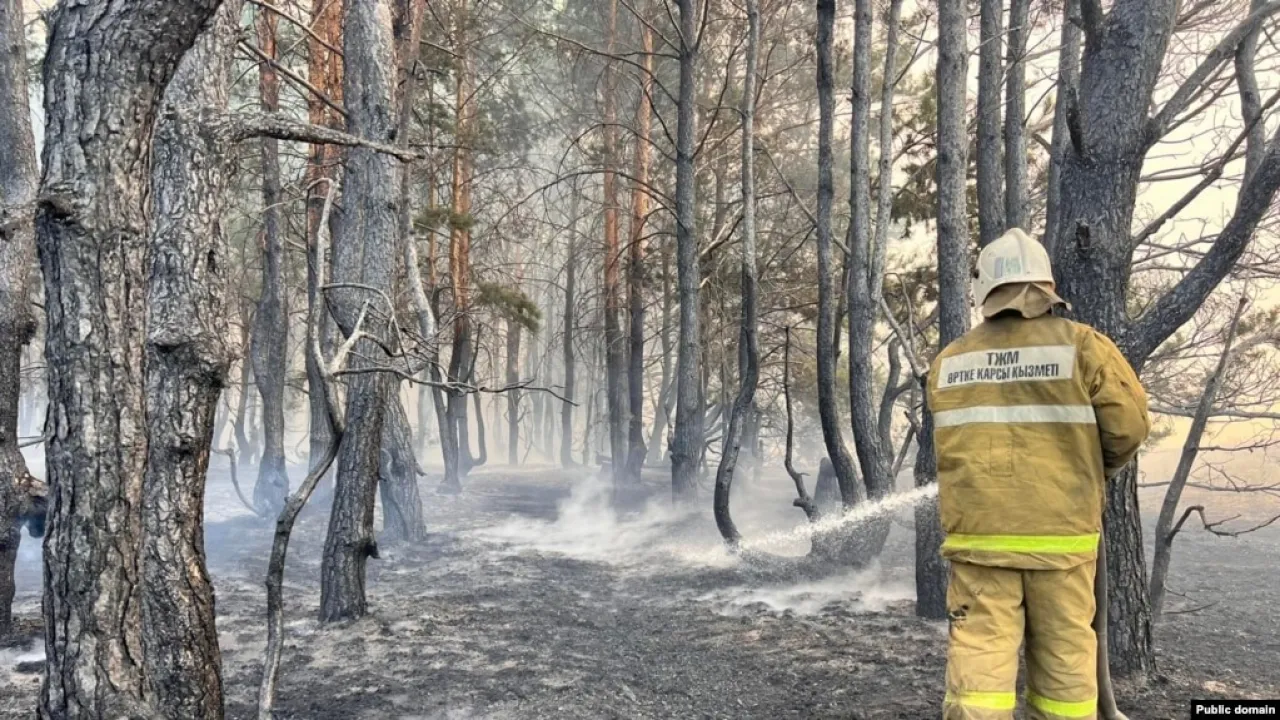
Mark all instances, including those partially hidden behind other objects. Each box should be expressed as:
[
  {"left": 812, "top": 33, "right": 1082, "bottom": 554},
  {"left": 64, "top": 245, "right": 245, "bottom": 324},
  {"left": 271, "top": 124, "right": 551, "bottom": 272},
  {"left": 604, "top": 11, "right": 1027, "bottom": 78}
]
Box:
[{"left": 471, "top": 474, "right": 936, "bottom": 615}]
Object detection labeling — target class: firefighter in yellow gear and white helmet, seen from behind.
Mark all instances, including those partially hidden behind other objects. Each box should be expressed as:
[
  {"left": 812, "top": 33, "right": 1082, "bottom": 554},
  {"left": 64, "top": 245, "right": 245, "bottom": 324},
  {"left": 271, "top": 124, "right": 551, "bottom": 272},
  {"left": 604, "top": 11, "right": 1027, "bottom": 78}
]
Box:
[{"left": 928, "top": 229, "right": 1151, "bottom": 720}]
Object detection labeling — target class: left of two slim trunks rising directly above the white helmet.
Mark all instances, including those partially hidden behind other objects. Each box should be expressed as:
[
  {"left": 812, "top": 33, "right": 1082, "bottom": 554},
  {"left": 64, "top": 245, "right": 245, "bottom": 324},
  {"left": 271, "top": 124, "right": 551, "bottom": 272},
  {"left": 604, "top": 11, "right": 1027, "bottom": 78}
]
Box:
[{"left": 978, "top": 0, "right": 1005, "bottom": 247}]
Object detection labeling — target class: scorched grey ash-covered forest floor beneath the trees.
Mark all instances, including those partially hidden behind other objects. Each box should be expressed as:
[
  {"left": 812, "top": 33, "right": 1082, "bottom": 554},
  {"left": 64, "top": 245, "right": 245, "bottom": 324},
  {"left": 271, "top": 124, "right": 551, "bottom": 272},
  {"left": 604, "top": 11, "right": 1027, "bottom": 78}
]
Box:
[{"left": 0, "top": 468, "right": 1280, "bottom": 720}]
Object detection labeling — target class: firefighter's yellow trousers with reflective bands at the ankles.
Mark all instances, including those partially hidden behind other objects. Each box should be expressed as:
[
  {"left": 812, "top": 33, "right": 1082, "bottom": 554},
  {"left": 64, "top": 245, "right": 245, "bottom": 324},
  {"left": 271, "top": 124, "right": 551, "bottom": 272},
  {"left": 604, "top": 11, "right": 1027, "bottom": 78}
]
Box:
[{"left": 942, "top": 562, "right": 1098, "bottom": 720}]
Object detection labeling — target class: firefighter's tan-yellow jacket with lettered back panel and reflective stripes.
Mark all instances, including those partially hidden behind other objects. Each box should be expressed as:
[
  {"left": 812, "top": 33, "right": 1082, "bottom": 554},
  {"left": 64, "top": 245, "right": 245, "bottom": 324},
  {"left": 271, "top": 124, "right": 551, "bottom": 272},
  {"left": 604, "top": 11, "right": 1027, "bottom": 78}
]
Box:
[{"left": 929, "top": 315, "right": 1151, "bottom": 570}]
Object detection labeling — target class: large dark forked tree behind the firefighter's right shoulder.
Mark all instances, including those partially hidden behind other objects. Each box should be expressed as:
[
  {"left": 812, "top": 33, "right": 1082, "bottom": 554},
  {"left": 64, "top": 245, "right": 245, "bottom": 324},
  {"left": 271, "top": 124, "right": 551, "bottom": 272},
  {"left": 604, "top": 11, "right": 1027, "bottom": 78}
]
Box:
[{"left": 1055, "top": 0, "right": 1280, "bottom": 679}]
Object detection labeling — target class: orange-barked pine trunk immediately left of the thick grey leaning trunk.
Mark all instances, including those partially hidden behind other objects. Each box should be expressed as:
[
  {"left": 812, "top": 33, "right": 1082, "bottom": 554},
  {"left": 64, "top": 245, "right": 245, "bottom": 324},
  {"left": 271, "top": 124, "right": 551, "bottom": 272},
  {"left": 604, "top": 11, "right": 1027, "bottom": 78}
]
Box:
[{"left": 303, "top": 0, "right": 344, "bottom": 469}]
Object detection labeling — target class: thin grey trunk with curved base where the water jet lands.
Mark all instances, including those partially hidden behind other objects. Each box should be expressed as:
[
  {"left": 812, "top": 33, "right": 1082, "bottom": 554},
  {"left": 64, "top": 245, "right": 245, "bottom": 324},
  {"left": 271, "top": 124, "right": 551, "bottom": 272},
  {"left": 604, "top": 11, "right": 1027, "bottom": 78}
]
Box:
[{"left": 714, "top": 0, "right": 760, "bottom": 544}]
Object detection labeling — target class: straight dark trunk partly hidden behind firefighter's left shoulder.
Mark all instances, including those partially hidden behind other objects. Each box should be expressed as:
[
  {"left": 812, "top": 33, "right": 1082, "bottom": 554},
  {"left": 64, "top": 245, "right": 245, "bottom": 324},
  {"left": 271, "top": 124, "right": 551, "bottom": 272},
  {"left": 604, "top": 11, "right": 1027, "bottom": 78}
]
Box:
[{"left": 915, "top": 0, "right": 969, "bottom": 618}]
